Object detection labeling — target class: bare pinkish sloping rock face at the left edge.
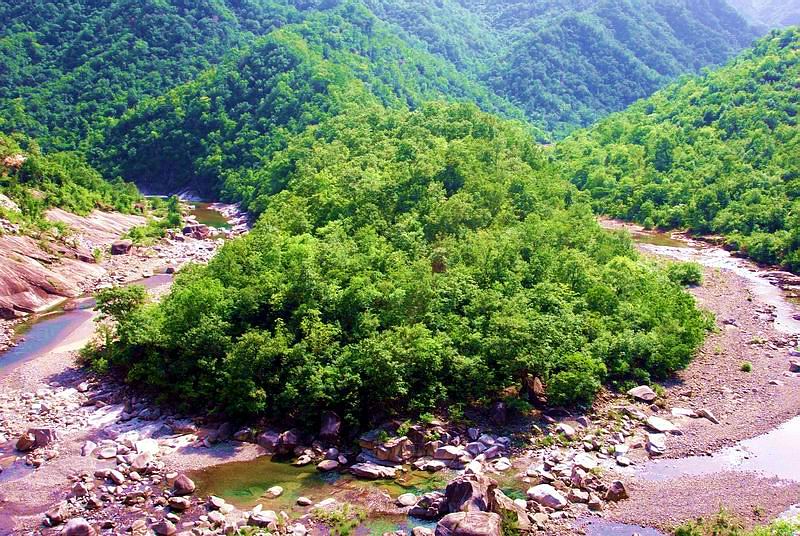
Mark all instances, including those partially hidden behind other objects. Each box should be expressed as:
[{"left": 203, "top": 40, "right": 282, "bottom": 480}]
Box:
[{"left": 0, "top": 209, "right": 145, "bottom": 319}]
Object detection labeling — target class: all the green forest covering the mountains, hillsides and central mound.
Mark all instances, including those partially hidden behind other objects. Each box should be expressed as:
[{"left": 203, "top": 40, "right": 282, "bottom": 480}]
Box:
[{"left": 0, "top": 0, "right": 798, "bottom": 427}]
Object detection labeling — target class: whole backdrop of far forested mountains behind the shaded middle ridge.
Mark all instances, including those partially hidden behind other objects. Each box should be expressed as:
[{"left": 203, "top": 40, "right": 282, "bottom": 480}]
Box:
[{"left": 0, "top": 0, "right": 754, "bottom": 149}]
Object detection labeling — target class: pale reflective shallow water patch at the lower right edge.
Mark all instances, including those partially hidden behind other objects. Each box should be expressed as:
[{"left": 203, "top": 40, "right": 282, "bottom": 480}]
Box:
[{"left": 638, "top": 416, "right": 800, "bottom": 482}]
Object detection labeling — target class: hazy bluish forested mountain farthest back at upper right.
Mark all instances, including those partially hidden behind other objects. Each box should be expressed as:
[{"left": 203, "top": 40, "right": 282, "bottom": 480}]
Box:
[{"left": 365, "top": 0, "right": 756, "bottom": 134}]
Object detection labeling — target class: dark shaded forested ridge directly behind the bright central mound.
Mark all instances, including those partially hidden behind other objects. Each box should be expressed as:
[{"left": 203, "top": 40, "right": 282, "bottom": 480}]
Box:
[{"left": 92, "top": 10, "right": 528, "bottom": 201}]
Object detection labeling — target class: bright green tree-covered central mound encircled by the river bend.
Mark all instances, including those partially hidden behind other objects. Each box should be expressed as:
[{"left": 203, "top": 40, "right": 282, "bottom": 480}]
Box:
[{"left": 90, "top": 103, "right": 708, "bottom": 425}]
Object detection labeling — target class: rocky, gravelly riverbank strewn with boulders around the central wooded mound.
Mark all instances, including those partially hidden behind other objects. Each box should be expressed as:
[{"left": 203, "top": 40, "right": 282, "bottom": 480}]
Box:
[{"left": 0, "top": 219, "right": 800, "bottom": 536}]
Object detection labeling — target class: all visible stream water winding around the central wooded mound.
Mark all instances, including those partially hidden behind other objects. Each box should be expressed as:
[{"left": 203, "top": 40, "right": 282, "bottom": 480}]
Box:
[{"left": 0, "top": 220, "right": 800, "bottom": 536}]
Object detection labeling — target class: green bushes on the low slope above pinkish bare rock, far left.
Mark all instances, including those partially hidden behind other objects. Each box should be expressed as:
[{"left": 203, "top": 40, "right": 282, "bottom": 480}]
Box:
[{"left": 0, "top": 133, "right": 140, "bottom": 222}]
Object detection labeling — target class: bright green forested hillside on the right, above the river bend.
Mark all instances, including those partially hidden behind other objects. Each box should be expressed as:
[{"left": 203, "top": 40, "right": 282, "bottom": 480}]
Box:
[{"left": 554, "top": 28, "right": 800, "bottom": 270}]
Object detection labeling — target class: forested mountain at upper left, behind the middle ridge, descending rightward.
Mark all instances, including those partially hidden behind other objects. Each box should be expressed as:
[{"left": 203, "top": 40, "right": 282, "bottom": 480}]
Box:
[{"left": 0, "top": 0, "right": 520, "bottom": 148}]
